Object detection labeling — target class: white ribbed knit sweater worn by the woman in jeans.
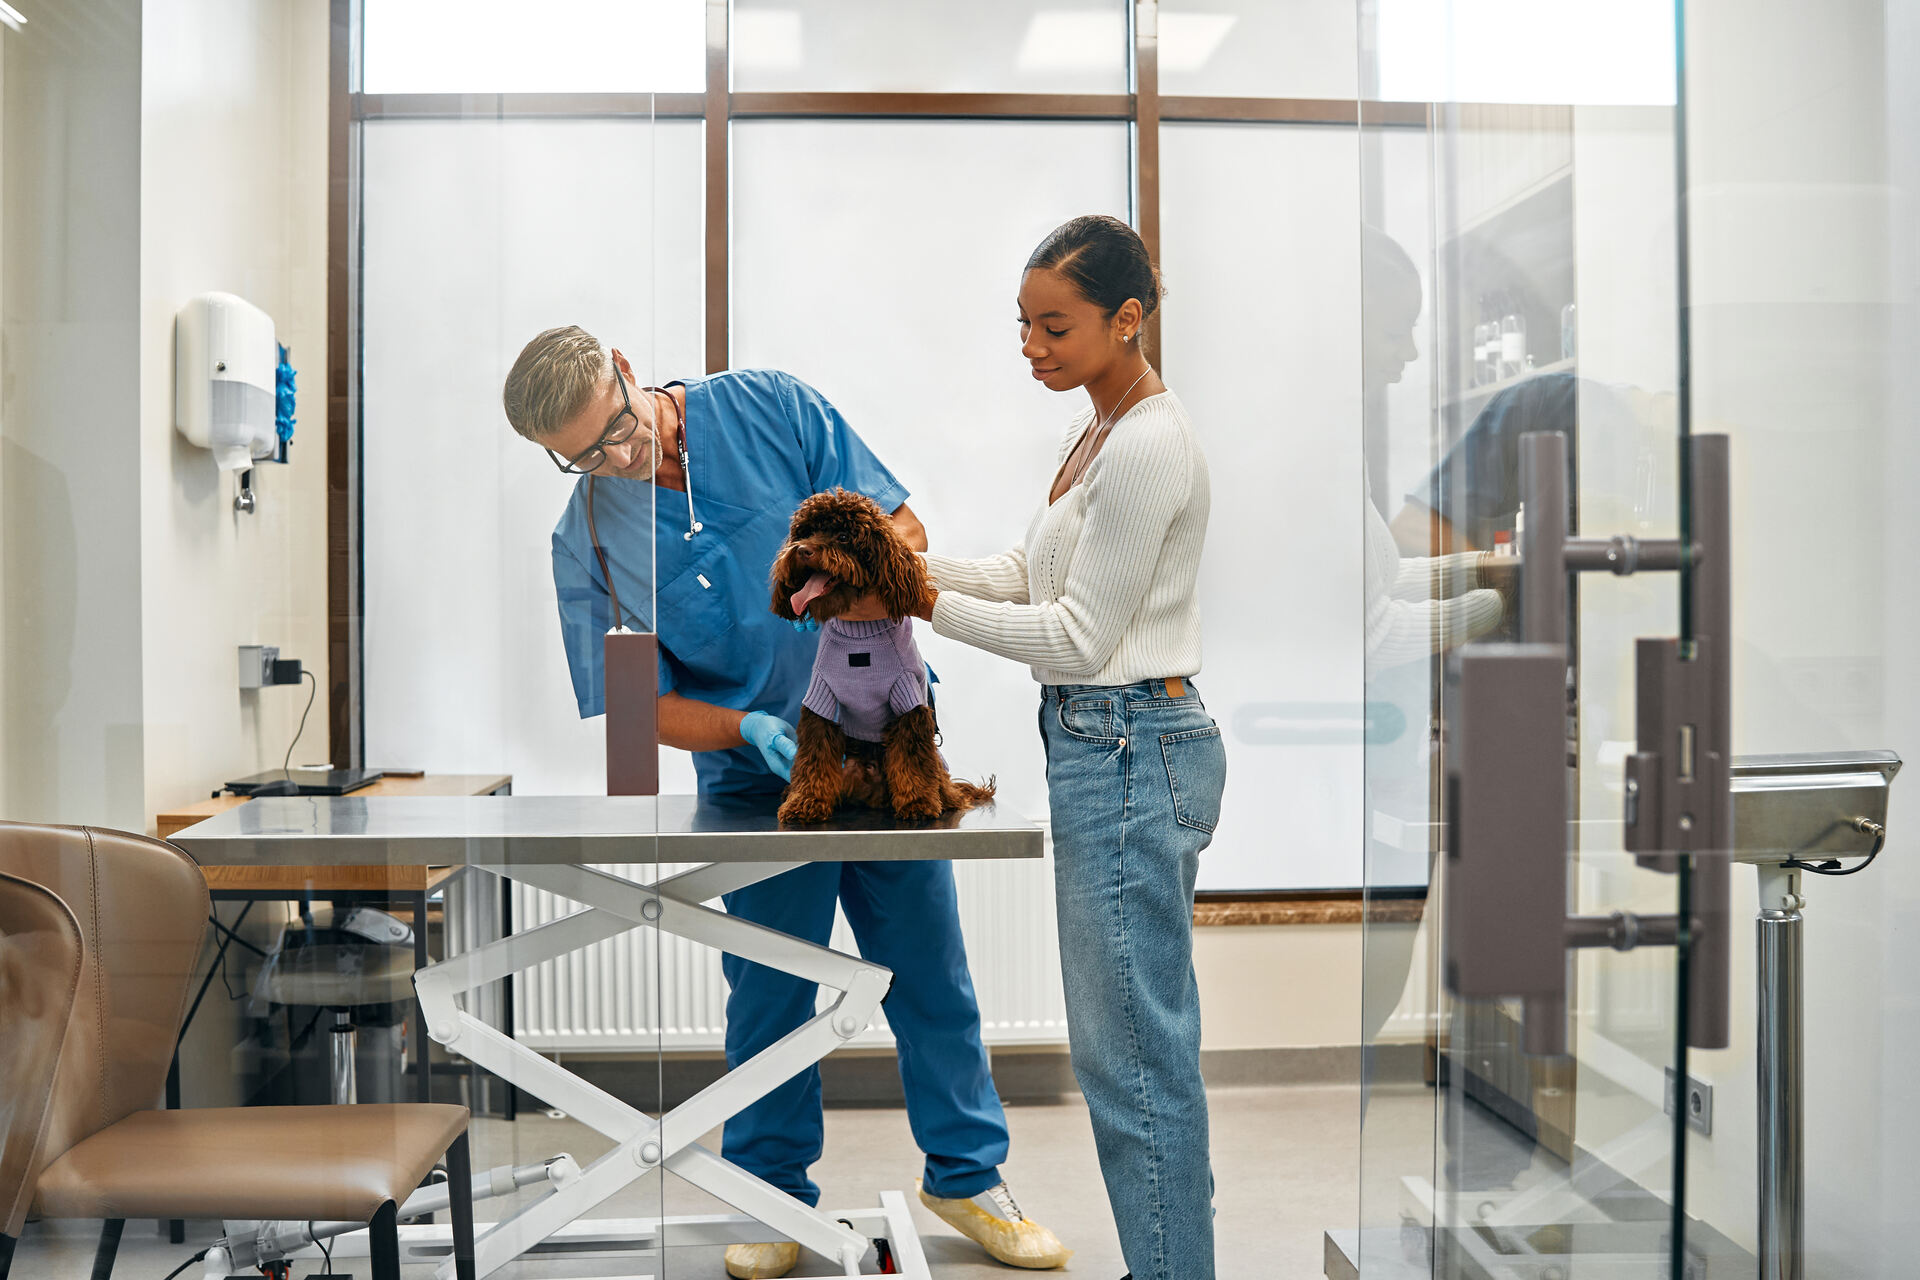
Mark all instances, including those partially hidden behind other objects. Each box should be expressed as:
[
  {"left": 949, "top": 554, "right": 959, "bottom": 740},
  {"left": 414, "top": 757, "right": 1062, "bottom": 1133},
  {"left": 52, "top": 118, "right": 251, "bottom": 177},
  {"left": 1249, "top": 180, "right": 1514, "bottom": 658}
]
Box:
[{"left": 927, "top": 391, "right": 1210, "bottom": 685}]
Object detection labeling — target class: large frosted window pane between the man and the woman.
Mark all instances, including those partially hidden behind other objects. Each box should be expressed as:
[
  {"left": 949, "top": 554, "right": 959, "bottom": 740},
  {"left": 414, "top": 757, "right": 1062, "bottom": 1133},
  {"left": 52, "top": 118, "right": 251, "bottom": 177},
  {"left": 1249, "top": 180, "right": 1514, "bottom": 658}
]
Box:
[{"left": 732, "top": 121, "right": 1127, "bottom": 816}]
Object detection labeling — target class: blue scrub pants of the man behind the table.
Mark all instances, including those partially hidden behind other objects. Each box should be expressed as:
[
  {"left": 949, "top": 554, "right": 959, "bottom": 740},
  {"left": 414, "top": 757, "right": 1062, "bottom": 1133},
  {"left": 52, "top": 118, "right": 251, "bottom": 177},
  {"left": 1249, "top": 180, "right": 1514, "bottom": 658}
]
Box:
[{"left": 720, "top": 862, "right": 1006, "bottom": 1205}]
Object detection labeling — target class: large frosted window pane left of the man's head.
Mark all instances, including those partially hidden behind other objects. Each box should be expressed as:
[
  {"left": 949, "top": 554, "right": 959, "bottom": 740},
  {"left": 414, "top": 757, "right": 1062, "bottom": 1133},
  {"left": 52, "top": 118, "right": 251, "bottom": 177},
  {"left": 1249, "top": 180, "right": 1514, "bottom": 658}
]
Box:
[{"left": 361, "top": 121, "right": 705, "bottom": 794}]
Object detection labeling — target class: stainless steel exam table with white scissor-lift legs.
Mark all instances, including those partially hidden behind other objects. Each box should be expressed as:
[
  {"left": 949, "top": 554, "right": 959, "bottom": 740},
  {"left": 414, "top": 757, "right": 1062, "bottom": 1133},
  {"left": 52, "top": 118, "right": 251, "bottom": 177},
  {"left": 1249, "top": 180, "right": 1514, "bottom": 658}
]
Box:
[{"left": 175, "top": 796, "right": 1043, "bottom": 1280}]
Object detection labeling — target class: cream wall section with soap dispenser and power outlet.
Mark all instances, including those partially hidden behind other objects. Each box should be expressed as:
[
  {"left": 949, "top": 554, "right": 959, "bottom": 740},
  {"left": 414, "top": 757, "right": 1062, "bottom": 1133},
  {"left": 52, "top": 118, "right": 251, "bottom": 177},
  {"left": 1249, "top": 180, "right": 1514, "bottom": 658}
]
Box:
[{"left": 138, "top": 0, "right": 328, "bottom": 829}]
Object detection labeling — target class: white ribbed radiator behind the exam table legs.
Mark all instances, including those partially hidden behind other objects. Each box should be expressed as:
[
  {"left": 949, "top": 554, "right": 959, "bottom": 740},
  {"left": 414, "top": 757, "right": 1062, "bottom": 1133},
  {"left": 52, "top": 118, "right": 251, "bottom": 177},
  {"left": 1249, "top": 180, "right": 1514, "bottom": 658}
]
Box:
[{"left": 447, "top": 840, "right": 1068, "bottom": 1052}]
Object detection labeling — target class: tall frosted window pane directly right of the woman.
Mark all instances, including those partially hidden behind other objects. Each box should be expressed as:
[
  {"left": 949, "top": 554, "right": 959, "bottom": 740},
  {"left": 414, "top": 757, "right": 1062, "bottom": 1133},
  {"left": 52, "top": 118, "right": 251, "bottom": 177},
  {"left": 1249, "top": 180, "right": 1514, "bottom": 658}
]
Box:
[{"left": 1160, "top": 125, "right": 1374, "bottom": 889}]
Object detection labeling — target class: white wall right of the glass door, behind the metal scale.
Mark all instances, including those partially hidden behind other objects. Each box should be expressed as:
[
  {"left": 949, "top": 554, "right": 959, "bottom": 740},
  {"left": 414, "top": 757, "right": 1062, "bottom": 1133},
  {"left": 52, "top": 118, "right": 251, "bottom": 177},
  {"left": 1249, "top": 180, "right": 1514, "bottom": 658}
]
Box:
[{"left": 1686, "top": 0, "right": 1920, "bottom": 1280}]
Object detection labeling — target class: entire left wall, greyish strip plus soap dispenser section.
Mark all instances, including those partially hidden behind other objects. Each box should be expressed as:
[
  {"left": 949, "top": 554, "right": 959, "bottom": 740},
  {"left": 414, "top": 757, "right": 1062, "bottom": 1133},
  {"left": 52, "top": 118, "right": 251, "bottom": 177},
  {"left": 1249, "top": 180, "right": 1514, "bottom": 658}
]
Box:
[{"left": 0, "top": 0, "right": 326, "bottom": 831}]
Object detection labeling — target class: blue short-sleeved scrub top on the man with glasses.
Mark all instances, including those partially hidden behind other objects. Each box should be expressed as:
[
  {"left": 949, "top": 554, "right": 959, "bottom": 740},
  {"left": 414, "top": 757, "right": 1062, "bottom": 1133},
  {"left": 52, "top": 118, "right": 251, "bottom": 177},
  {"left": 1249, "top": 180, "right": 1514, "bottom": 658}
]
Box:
[{"left": 553, "top": 368, "right": 906, "bottom": 794}]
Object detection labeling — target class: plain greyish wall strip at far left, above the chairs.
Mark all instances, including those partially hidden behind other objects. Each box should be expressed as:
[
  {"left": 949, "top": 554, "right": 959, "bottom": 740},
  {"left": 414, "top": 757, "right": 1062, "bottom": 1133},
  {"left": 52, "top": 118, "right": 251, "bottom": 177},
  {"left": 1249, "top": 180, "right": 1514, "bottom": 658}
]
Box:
[{"left": 0, "top": 0, "right": 146, "bottom": 829}]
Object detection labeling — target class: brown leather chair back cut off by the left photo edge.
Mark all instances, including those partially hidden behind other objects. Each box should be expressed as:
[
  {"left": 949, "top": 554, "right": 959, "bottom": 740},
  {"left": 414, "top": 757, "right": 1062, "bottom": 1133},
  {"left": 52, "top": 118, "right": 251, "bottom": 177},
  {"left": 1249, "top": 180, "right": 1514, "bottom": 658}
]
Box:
[{"left": 0, "top": 875, "right": 81, "bottom": 1274}]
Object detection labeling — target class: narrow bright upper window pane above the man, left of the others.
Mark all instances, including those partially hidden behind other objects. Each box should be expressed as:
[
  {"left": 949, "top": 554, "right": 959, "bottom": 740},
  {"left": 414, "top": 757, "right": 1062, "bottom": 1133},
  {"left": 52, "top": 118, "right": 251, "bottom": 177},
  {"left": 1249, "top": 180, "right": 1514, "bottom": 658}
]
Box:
[{"left": 361, "top": 0, "right": 707, "bottom": 94}]
